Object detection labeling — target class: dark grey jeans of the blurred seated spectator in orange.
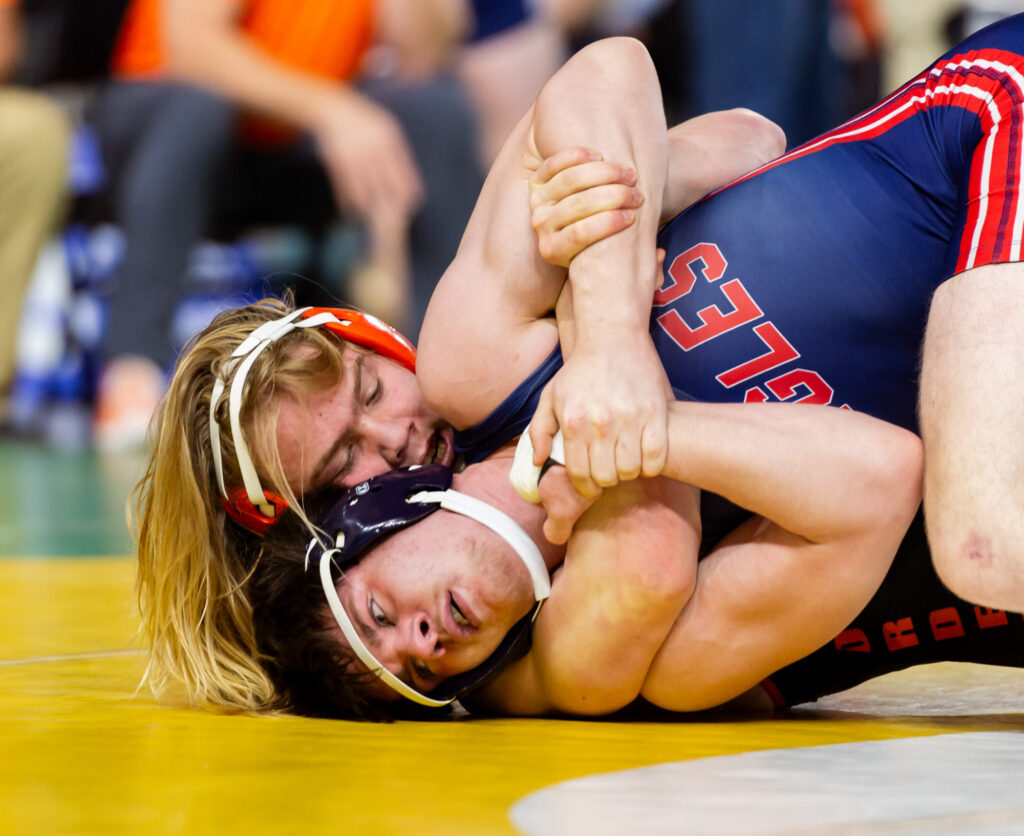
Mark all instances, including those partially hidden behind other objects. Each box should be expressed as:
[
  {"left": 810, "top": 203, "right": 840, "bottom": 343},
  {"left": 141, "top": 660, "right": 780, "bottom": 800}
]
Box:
[{"left": 91, "top": 79, "right": 482, "bottom": 366}]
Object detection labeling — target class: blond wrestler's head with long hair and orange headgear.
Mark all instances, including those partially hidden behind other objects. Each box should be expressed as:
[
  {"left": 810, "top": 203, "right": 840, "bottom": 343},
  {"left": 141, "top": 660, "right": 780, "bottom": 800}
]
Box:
[{"left": 133, "top": 299, "right": 451, "bottom": 710}]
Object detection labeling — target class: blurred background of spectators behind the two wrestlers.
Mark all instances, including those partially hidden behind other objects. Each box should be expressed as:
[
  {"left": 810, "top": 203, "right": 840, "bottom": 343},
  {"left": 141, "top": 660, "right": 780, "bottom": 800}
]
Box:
[{"left": 0, "top": 0, "right": 1024, "bottom": 463}]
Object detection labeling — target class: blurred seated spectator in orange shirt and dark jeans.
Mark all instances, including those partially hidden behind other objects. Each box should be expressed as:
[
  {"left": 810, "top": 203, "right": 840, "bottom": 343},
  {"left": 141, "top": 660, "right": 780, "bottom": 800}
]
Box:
[{"left": 93, "top": 0, "right": 480, "bottom": 447}]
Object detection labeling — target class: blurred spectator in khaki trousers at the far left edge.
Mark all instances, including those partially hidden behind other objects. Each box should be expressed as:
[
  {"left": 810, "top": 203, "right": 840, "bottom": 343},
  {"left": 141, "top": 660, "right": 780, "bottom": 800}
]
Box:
[{"left": 0, "top": 0, "right": 70, "bottom": 420}]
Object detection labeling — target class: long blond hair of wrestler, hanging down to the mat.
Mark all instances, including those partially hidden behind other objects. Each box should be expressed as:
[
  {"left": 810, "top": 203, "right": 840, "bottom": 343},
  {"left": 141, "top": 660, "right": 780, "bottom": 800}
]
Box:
[{"left": 133, "top": 297, "right": 343, "bottom": 711}]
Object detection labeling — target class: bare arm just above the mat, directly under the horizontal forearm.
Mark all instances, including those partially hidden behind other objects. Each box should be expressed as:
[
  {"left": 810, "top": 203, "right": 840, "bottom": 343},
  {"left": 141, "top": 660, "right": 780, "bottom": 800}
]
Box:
[{"left": 641, "top": 510, "right": 909, "bottom": 711}]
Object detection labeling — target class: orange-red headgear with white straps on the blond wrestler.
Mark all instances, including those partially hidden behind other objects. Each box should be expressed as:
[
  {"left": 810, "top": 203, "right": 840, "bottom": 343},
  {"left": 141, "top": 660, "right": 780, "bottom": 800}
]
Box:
[{"left": 210, "top": 307, "right": 416, "bottom": 536}]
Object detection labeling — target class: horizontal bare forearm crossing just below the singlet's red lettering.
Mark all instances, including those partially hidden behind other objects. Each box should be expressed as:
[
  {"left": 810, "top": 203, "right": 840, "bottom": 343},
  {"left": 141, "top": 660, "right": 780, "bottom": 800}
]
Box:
[{"left": 664, "top": 402, "right": 922, "bottom": 543}]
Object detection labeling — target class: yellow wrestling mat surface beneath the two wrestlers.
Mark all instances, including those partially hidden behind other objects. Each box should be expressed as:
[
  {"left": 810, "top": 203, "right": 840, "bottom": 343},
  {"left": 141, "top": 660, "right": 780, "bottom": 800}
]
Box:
[{"left": 0, "top": 557, "right": 1024, "bottom": 836}]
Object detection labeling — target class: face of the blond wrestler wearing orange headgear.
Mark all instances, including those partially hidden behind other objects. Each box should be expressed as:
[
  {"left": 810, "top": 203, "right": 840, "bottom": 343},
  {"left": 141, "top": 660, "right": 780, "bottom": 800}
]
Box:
[{"left": 276, "top": 347, "right": 455, "bottom": 496}]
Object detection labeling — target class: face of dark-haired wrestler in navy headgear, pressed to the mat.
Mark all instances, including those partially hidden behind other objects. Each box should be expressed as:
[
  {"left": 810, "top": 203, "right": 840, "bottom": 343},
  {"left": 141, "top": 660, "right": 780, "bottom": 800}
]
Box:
[{"left": 334, "top": 511, "right": 535, "bottom": 700}]
